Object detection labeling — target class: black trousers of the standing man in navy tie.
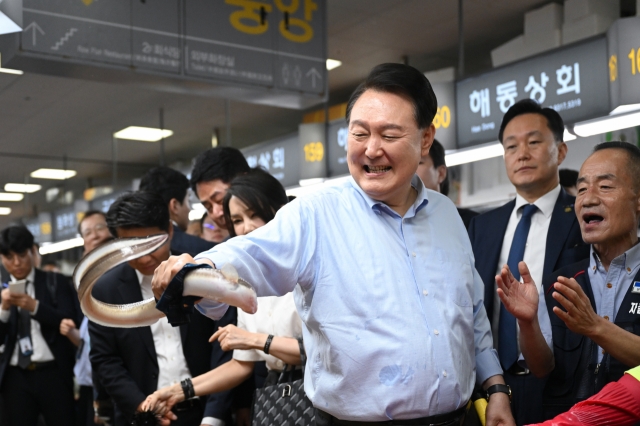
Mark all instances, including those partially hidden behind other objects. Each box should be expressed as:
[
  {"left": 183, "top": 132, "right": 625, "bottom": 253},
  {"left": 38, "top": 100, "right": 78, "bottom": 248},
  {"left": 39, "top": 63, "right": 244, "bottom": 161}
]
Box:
[{"left": 504, "top": 371, "right": 547, "bottom": 426}]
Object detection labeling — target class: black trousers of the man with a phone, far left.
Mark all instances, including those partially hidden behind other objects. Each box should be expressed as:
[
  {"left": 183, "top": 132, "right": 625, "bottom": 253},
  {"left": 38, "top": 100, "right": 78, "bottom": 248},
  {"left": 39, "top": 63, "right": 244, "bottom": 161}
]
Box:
[{"left": 2, "top": 366, "right": 75, "bottom": 426}]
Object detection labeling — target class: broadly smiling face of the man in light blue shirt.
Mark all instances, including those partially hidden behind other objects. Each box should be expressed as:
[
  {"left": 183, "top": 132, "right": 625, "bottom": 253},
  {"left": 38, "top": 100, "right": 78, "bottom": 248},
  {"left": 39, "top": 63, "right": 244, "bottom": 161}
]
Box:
[{"left": 347, "top": 90, "right": 435, "bottom": 210}]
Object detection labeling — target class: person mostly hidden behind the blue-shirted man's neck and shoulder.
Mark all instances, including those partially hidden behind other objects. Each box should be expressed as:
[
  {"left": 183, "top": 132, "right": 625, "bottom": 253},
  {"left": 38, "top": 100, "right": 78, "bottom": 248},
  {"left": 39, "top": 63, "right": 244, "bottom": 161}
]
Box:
[{"left": 416, "top": 139, "right": 478, "bottom": 229}]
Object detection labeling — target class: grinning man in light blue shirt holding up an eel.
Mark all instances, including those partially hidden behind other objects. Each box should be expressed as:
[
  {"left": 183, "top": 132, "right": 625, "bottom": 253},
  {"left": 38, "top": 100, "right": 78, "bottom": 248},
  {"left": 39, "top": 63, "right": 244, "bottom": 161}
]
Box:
[{"left": 153, "top": 64, "right": 514, "bottom": 425}]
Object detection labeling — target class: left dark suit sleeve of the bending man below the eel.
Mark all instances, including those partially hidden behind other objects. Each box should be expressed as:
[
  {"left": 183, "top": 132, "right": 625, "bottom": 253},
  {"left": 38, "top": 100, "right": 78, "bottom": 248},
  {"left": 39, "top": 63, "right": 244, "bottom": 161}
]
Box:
[{"left": 89, "top": 321, "right": 147, "bottom": 418}]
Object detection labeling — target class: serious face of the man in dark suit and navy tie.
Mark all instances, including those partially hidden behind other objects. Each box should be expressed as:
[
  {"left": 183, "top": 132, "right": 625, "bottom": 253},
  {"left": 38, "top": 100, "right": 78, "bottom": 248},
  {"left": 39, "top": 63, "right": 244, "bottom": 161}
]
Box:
[{"left": 502, "top": 114, "right": 567, "bottom": 201}]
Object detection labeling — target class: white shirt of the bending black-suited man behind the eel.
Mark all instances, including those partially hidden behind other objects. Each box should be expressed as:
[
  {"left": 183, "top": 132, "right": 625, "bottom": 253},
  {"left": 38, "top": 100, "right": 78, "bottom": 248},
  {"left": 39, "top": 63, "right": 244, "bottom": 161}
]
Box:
[{"left": 136, "top": 271, "right": 191, "bottom": 389}]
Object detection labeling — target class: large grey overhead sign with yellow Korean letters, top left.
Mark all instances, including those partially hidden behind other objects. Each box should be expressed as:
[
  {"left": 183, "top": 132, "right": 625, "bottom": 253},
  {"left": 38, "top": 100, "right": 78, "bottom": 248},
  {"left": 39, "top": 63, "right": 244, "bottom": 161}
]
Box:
[{"left": 0, "top": 0, "right": 327, "bottom": 108}]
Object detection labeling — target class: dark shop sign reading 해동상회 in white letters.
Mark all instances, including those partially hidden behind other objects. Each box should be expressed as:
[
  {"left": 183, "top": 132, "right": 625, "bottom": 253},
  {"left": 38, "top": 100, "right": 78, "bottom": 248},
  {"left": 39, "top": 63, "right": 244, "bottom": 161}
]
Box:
[{"left": 458, "top": 37, "right": 610, "bottom": 148}]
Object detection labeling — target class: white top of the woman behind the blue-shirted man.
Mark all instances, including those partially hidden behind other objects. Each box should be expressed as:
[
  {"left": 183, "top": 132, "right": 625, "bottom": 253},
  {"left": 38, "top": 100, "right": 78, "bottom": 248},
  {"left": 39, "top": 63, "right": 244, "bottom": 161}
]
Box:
[{"left": 233, "top": 293, "right": 302, "bottom": 371}]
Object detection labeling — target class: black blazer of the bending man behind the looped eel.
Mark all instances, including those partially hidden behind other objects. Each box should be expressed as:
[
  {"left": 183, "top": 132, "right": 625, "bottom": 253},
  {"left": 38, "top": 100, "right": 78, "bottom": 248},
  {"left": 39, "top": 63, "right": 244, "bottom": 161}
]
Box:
[{"left": 89, "top": 264, "right": 216, "bottom": 425}]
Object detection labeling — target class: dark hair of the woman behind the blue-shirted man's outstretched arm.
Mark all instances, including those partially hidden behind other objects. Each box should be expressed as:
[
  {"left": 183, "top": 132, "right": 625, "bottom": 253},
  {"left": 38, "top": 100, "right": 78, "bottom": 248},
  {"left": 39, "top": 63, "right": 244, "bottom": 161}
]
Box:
[{"left": 222, "top": 167, "right": 289, "bottom": 237}]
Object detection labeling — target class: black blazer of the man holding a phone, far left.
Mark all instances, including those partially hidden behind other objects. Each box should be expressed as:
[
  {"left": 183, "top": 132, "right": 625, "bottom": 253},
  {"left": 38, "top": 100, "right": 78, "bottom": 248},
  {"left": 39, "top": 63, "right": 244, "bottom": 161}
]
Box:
[{"left": 0, "top": 269, "right": 82, "bottom": 385}]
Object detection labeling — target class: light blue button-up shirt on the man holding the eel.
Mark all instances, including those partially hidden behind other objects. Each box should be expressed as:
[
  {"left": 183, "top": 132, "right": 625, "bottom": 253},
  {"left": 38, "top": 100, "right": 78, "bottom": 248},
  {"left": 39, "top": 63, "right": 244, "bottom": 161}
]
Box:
[{"left": 198, "top": 176, "right": 502, "bottom": 421}]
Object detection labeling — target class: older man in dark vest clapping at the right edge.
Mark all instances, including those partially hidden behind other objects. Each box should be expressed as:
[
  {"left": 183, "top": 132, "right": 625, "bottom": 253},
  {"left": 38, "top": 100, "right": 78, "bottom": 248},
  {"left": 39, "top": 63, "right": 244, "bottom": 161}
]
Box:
[{"left": 498, "top": 142, "right": 640, "bottom": 418}]
